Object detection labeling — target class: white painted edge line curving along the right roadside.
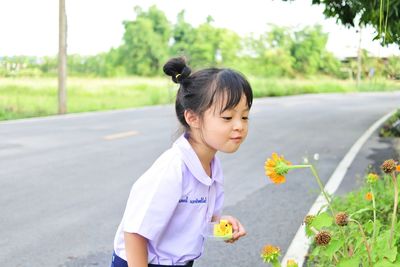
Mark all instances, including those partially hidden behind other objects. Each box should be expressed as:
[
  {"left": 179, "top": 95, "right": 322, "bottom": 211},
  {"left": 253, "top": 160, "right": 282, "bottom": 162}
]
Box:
[{"left": 281, "top": 109, "right": 396, "bottom": 266}]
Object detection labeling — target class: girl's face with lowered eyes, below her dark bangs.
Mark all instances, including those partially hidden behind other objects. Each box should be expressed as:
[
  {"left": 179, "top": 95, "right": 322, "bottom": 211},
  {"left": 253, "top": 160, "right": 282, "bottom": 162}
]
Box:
[{"left": 201, "top": 95, "right": 249, "bottom": 153}]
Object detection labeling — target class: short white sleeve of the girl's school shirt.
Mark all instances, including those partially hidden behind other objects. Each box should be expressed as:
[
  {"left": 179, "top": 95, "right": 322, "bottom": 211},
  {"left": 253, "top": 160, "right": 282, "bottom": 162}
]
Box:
[{"left": 122, "top": 151, "right": 182, "bottom": 243}]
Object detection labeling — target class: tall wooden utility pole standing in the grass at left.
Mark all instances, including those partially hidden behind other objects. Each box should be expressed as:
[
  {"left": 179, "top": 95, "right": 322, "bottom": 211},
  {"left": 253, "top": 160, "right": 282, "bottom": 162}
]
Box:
[{"left": 58, "top": 0, "right": 67, "bottom": 114}]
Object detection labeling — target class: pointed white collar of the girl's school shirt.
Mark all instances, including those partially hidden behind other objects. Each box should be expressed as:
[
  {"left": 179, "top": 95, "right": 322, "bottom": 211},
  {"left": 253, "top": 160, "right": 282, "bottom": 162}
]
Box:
[{"left": 174, "top": 133, "right": 223, "bottom": 186}]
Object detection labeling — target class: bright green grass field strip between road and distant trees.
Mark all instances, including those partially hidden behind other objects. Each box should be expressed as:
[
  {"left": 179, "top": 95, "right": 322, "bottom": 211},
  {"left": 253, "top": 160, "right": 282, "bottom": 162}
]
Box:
[{"left": 0, "top": 77, "right": 400, "bottom": 120}]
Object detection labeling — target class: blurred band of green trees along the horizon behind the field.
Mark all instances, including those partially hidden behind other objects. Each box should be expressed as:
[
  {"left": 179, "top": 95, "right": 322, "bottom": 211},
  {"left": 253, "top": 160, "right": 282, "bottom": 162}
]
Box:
[{"left": 0, "top": 4, "right": 400, "bottom": 79}]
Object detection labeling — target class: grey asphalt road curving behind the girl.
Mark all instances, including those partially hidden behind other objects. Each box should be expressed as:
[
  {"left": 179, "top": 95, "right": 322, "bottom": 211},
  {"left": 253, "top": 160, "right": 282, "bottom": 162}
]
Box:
[{"left": 0, "top": 92, "right": 400, "bottom": 267}]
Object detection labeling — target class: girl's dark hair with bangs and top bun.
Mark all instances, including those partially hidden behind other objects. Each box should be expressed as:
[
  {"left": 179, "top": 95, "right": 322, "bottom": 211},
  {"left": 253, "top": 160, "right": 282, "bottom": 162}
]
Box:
[{"left": 163, "top": 57, "right": 253, "bottom": 130}]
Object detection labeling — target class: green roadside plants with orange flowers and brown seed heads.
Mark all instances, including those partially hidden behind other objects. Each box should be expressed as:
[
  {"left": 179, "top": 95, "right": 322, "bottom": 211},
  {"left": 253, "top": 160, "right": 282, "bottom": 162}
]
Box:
[{"left": 265, "top": 153, "right": 400, "bottom": 267}]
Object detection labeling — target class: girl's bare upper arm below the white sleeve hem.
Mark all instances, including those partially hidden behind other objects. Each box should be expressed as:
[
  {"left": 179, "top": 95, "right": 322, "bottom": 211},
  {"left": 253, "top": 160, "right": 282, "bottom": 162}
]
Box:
[{"left": 124, "top": 232, "right": 148, "bottom": 267}]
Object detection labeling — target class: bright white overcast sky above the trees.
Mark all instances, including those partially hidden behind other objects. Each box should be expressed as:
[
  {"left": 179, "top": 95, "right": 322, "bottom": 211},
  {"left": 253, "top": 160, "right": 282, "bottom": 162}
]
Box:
[{"left": 0, "top": 0, "right": 400, "bottom": 58}]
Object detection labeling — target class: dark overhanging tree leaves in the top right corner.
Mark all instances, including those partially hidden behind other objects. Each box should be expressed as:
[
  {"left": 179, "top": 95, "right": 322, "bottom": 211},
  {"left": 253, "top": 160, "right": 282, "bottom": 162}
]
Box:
[{"left": 312, "top": 0, "right": 400, "bottom": 45}]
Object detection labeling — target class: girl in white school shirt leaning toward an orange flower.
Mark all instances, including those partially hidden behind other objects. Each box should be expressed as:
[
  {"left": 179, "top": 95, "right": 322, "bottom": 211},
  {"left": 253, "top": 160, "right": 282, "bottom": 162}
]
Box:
[{"left": 111, "top": 58, "right": 253, "bottom": 267}]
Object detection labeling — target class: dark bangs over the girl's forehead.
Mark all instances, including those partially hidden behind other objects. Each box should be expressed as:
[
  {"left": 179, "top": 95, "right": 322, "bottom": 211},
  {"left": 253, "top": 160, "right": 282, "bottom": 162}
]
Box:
[{"left": 212, "top": 69, "right": 253, "bottom": 113}]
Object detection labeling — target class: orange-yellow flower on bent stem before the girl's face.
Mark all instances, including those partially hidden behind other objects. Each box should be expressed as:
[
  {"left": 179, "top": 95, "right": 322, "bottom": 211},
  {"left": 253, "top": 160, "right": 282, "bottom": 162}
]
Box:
[{"left": 264, "top": 153, "right": 291, "bottom": 184}]
